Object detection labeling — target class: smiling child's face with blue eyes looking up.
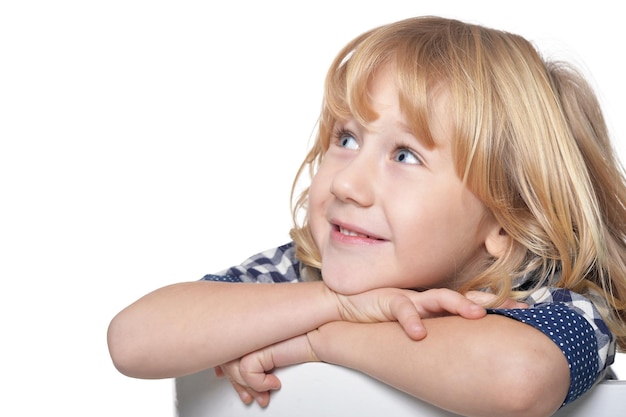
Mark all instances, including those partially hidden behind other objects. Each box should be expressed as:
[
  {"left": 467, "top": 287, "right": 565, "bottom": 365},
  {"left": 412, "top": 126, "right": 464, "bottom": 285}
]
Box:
[{"left": 309, "top": 67, "right": 498, "bottom": 294}]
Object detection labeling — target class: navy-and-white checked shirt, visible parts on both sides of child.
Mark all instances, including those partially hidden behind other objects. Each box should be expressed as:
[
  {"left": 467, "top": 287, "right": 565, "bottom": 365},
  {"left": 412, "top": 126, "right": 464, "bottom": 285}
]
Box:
[{"left": 203, "top": 242, "right": 616, "bottom": 405}]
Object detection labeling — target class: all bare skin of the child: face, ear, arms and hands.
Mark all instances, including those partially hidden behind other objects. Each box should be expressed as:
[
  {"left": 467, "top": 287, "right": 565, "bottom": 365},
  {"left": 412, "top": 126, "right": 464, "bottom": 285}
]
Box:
[{"left": 108, "top": 68, "right": 569, "bottom": 416}]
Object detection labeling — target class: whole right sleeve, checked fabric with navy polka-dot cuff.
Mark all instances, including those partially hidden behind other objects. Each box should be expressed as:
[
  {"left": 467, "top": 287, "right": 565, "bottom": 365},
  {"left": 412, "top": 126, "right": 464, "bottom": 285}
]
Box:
[{"left": 488, "top": 288, "right": 616, "bottom": 405}]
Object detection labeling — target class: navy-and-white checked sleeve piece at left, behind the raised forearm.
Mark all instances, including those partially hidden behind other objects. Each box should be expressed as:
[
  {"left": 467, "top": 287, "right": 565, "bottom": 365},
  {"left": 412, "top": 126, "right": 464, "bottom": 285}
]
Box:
[{"left": 202, "top": 242, "right": 300, "bottom": 283}]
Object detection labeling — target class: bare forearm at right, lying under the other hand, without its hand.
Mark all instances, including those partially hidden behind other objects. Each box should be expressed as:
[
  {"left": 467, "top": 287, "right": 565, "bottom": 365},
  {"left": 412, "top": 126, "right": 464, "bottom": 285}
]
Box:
[{"left": 309, "top": 315, "right": 569, "bottom": 416}]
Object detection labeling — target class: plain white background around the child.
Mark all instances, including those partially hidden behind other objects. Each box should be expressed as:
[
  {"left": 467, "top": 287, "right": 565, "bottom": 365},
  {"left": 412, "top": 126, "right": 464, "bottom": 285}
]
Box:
[{"left": 0, "top": 0, "right": 626, "bottom": 417}]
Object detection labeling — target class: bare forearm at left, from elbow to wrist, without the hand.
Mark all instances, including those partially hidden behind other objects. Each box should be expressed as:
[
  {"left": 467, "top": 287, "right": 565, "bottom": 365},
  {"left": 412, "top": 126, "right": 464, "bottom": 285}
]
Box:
[{"left": 108, "top": 281, "right": 338, "bottom": 378}]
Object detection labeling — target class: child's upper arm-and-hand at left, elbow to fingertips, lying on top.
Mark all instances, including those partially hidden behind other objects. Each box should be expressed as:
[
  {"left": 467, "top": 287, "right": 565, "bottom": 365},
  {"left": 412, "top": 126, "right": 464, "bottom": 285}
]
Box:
[{"left": 108, "top": 281, "right": 485, "bottom": 378}]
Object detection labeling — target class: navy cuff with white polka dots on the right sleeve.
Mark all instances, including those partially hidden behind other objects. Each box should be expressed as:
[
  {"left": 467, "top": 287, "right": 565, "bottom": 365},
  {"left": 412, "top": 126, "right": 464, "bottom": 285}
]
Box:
[{"left": 488, "top": 303, "right": 598, "bottom": 405}]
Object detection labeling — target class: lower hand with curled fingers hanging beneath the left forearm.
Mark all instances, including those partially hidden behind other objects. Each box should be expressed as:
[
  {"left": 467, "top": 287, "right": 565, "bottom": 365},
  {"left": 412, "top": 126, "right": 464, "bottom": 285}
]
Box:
[{"left": 215, "top": 335, "right": 319, "bottom": 407}]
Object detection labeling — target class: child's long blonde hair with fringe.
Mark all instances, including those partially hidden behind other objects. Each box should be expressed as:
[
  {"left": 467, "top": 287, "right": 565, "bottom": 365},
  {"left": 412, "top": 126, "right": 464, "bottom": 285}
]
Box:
[{"left": 291, "top": 17, "right": 626, "bottom": 349}]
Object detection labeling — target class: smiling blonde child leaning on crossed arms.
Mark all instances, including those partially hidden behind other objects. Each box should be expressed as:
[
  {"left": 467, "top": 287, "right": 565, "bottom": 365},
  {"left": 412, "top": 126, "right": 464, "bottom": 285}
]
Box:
[{"left": 108, "top": 17, "right": 626, "bottom": 415}]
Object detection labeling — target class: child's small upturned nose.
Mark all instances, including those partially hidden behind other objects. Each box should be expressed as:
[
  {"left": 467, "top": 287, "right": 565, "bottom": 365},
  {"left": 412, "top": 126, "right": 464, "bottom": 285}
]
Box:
[{"left": 330, "top": 155, "right": 377, "bottom": 207}]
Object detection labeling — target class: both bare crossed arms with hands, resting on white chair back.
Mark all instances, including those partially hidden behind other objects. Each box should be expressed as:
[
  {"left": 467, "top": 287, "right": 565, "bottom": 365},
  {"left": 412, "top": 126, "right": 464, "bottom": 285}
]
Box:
[{"left": 108, "top": 282, "right": 569, "bottom": 416}]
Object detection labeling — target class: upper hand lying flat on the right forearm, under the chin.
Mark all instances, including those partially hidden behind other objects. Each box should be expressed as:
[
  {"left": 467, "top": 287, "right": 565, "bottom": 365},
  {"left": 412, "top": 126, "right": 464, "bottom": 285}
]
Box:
[{"left": 335, "top": 288, "right": 486, "bottom": 340}]
